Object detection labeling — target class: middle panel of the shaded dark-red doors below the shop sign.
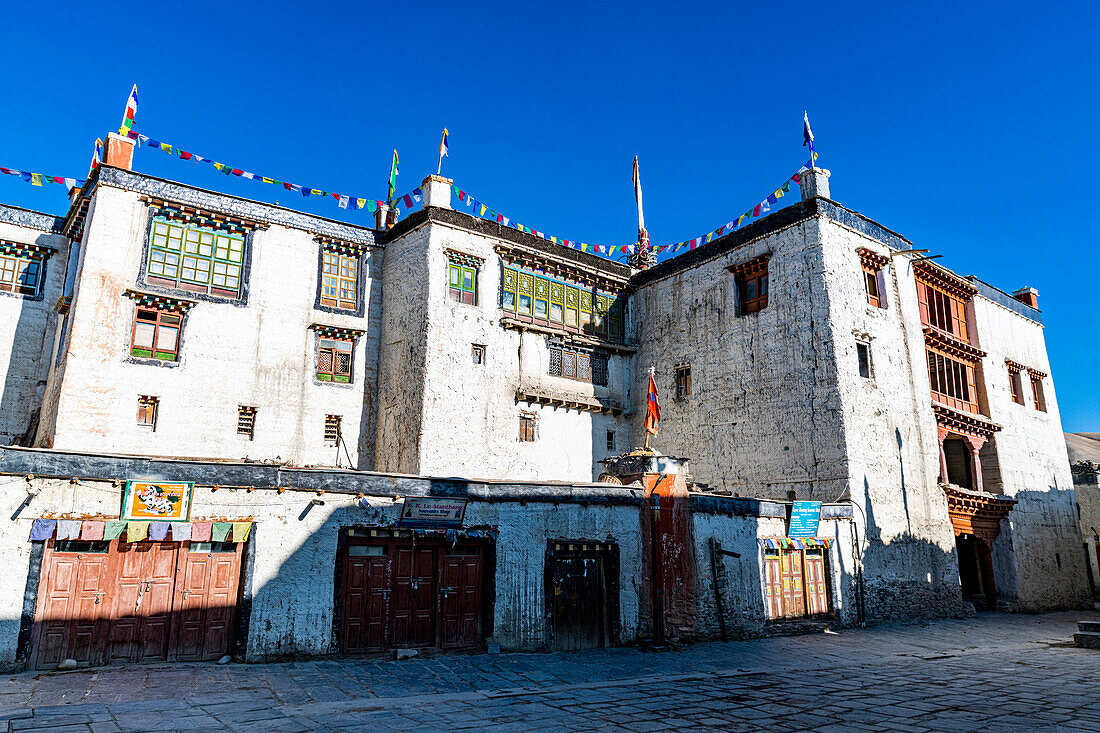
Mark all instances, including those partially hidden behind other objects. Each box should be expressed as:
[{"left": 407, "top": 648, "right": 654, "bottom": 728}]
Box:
[{"left": 391, "top": 545, "right": 437, "bottom": 647}]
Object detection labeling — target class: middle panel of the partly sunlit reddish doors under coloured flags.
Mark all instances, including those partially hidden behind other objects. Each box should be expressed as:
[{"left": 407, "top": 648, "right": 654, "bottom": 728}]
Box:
[{"left": 107, "top": 541, "right": 178, "bottom": 661}]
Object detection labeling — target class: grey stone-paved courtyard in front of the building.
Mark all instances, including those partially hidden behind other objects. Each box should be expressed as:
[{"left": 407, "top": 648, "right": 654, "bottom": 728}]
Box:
[{"left": 0, "top": 612, "right": 1100, "bottom": 733}]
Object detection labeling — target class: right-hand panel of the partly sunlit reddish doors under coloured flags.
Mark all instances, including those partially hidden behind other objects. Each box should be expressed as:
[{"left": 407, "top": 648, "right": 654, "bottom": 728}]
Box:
[{"left": 169, "top": 543, "right": 242, "bottom": 661}]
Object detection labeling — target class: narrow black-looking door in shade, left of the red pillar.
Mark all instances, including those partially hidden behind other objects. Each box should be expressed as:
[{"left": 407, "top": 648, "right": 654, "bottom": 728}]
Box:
[{"left": 550, "top": 556, "right": 605, "bottom": 649}]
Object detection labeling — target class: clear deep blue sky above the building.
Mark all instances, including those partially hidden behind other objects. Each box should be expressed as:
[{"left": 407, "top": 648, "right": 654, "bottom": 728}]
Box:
[{"left": 0, "top": 2, "right": 1100, "bottom": 431}]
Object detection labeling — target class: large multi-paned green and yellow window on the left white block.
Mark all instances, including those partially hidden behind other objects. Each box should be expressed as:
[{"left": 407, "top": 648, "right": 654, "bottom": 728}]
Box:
[{"left": 145, "top": 218, "right": 244, "bottom": 298}]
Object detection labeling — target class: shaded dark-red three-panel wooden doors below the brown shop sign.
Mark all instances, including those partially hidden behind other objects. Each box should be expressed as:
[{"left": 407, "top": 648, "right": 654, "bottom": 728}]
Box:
[{"left": 337, "top": 541, "right": 483, "bottom": 654}]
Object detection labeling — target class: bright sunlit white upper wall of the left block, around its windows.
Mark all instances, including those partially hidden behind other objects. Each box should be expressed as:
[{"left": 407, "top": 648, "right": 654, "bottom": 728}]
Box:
[{"left": 36, "top": 185, "right": 381, "bottom": 468}]
